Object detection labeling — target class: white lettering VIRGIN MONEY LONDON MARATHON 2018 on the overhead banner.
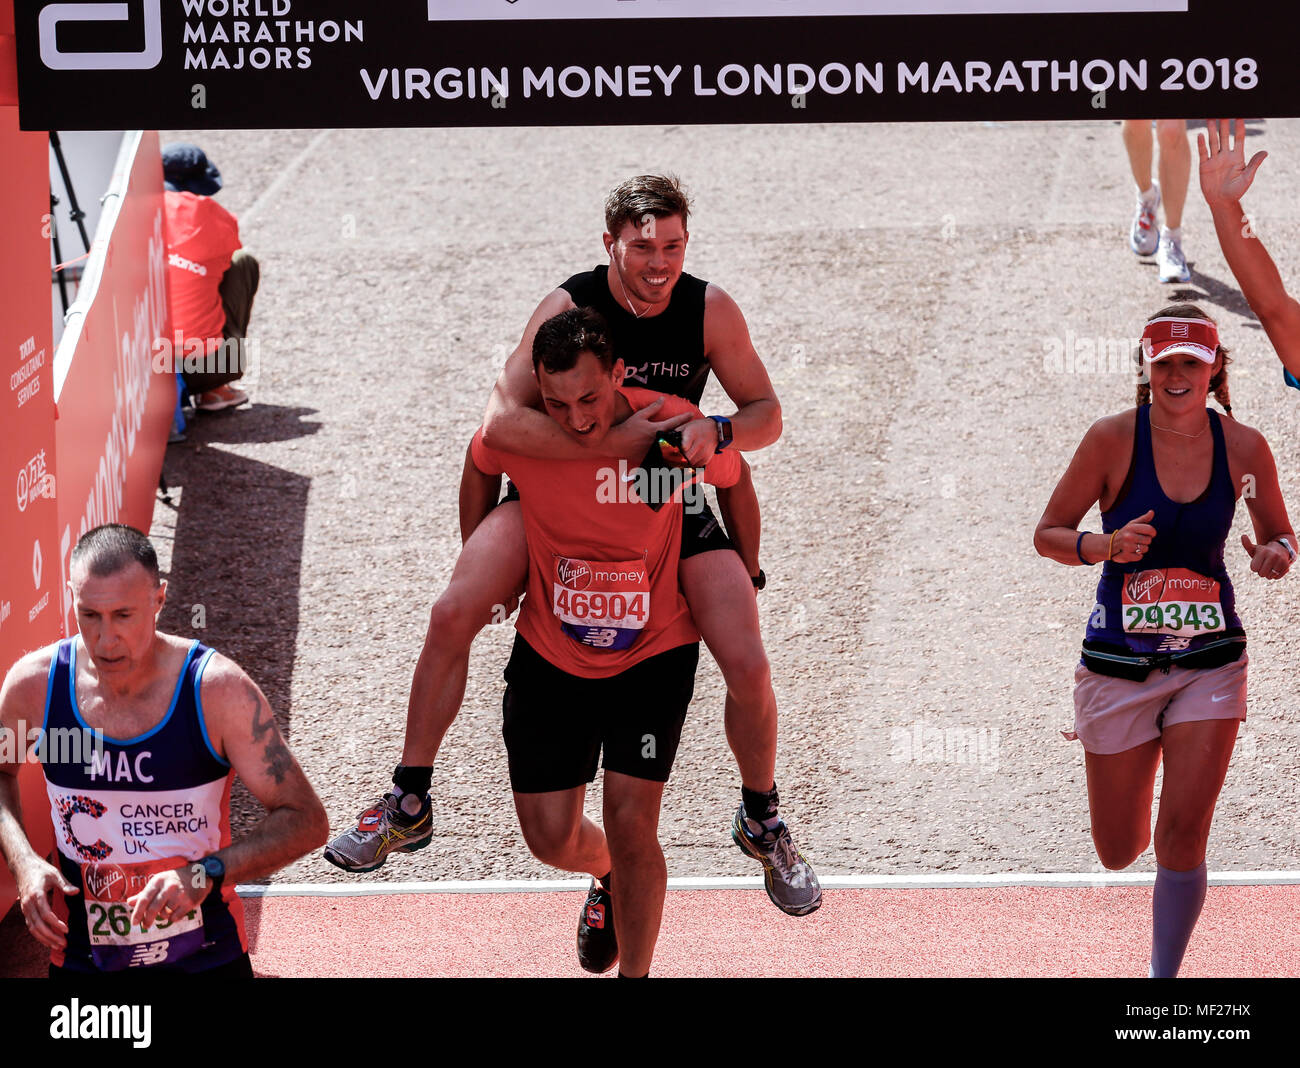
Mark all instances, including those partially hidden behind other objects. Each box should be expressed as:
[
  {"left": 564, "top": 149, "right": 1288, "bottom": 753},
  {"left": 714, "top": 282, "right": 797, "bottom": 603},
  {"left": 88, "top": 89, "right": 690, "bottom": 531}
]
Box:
[{"left": 358, "top": 57, "right": 1258, "bottom": 100}]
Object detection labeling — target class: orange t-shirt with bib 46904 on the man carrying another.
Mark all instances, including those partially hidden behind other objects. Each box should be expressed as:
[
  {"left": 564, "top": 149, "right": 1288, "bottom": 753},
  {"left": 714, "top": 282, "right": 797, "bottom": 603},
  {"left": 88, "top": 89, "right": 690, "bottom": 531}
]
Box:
[{"left": 471, "top": 387, "right": 740, "bottom": 678}]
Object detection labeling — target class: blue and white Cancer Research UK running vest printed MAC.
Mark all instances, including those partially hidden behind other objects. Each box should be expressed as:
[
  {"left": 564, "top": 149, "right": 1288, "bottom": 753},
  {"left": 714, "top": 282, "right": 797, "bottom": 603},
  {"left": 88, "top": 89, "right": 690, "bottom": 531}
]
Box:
[{"left": 42, "top": 638, "right": 248, "bottom": 972}]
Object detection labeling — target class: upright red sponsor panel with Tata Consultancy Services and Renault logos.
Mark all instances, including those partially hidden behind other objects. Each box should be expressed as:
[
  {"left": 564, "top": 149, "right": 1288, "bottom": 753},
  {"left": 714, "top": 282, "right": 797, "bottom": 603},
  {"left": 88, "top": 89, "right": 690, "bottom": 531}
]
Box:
[{"left": 0, "top": 108, "right": 61, "bottom": 916}]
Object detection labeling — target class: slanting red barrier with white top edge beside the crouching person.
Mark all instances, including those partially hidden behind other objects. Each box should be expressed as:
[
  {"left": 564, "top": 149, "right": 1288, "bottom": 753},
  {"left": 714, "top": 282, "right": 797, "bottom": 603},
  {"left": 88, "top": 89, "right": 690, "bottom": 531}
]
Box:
[{"left": 55, "top": 131, "right": 176, "bottom": 634}]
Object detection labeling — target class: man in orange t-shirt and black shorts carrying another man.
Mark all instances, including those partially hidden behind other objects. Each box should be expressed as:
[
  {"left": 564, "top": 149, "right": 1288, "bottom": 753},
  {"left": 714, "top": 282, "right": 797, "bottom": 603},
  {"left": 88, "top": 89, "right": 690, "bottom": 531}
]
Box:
[{"left": 471, "top": 308, "right": 740, "bottom": 978}]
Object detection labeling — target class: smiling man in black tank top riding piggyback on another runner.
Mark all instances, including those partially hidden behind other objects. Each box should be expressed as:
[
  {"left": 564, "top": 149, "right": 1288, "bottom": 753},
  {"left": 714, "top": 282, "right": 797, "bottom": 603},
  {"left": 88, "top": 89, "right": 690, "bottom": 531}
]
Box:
[{"left": 325, "top": 175, "right": 822, "bottom": 916}]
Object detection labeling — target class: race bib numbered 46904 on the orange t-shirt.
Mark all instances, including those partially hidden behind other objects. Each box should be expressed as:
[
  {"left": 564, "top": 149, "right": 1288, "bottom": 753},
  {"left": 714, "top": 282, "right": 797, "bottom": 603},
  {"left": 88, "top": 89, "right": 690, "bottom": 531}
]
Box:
[{"left": 551, "top": 556, "right": 650, "bottom": 650}]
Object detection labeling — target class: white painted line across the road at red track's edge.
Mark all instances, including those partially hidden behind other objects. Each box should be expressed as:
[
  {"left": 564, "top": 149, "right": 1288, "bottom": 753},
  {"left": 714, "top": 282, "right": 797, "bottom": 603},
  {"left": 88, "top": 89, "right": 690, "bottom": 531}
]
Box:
[{"left": 235, "top": 872, "right": 1300, "bottom": 898}]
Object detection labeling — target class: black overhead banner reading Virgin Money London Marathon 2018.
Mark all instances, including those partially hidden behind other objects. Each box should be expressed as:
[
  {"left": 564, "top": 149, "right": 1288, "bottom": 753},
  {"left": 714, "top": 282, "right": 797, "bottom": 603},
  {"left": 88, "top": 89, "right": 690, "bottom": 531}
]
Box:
[{"left": 16, "top": 0, "right": 1300, "bottom": 130}]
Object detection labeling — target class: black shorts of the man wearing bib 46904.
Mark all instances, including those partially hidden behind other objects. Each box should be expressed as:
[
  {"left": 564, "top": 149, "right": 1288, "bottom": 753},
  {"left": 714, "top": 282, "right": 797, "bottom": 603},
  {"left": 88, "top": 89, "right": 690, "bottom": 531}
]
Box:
[{"left": 502, "top": 631, "right": 699, "bottom": 794}]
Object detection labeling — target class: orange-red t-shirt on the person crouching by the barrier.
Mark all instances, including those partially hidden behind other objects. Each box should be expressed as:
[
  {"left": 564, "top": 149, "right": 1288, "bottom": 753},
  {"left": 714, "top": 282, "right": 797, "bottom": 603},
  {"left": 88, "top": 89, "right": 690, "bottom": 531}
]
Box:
[{"left": 163, "top": 190, "right": 243, "bottom": 340}]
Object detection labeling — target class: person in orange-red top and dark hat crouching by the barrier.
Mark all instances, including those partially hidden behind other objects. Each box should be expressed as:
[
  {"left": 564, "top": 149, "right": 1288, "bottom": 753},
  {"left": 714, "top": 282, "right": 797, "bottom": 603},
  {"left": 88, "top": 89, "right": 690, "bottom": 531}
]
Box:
[{"left": 163, "top": 142, "right": 260, "bottom": 412}]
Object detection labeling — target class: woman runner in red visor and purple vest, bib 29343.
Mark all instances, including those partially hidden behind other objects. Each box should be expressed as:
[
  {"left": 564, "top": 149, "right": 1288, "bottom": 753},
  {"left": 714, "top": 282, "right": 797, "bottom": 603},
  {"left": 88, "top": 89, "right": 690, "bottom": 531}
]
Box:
[{"left": 1034, "top": 304, "right": 1296, "bottom": 977}]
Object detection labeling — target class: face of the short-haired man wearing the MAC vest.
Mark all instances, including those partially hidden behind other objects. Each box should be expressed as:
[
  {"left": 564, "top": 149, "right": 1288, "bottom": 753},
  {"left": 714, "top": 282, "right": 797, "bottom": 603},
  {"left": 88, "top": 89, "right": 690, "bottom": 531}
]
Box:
[{"left": 68, "top": 560, "right": 166, "bottom": 676}]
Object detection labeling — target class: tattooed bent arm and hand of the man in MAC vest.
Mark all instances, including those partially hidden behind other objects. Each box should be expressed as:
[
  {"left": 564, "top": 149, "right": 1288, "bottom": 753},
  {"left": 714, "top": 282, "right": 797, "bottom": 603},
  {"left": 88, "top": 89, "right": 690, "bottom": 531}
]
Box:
[{"left": 127, "top": 654, "right": 329, "bottom": 925}]
